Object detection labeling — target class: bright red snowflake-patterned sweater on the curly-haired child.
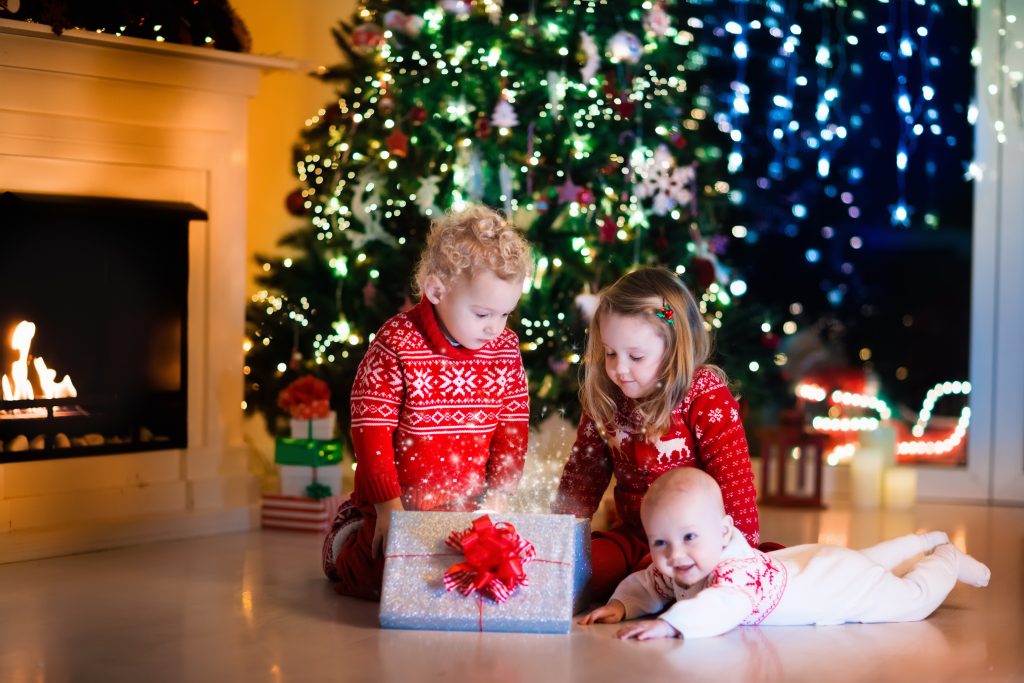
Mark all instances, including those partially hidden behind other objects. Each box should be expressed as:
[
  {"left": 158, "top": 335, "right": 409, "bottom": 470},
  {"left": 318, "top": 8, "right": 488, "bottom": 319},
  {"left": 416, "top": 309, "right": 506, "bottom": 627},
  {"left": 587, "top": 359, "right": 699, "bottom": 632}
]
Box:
[{"left": 351, "top": 299, "right": 529, "bottom": 510}]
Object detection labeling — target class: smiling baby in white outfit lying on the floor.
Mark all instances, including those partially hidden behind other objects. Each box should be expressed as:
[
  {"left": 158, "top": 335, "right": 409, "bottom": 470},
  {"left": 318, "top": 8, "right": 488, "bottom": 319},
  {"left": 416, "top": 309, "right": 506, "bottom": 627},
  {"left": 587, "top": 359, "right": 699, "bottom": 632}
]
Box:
[{"left": 580, "top": 467, "right": 990, "bottom": 640}]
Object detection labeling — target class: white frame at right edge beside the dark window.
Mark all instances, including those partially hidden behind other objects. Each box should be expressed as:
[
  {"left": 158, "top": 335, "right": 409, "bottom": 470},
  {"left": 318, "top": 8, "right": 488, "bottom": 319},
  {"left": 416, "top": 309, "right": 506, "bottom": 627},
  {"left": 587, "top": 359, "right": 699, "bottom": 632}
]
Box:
[{"left": 958, "top": 0, "right": 1024, "bottom": 503}]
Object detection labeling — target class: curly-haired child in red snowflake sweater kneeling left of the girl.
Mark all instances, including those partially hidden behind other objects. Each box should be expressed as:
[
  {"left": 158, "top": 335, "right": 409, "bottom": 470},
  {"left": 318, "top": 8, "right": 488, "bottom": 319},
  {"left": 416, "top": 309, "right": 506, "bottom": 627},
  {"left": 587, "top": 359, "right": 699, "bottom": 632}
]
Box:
[{"left": 324, "top": 207, "right": 532, "bottom": 600}]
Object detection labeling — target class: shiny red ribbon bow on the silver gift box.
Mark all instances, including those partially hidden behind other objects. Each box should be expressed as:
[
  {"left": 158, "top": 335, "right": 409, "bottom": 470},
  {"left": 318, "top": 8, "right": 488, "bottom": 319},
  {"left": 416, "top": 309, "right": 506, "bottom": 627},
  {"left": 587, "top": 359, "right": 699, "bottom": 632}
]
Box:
[{"left": 444, "top": 515, "right": 537, "bottom": 603}]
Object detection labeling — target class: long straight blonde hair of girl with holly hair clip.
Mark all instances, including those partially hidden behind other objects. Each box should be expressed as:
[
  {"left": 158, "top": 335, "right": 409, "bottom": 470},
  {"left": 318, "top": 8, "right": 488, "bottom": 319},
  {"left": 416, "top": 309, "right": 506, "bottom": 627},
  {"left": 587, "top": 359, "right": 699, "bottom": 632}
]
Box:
[{"left": 580, "top": 267, "right": 725, "bottom": 441}]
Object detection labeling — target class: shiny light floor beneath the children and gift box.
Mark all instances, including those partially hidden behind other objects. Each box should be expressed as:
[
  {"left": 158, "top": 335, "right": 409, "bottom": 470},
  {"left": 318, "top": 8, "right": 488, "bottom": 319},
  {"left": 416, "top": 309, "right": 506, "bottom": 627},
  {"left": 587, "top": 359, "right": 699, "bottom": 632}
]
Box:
[{"left": 0, "top": 505, "right": 1024, "bottom": 683}]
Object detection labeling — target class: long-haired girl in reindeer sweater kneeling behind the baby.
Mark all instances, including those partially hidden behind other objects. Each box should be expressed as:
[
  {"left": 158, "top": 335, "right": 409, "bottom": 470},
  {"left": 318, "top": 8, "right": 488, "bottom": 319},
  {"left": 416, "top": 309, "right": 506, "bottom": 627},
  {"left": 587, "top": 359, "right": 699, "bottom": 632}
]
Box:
[{"left": 553, "top": 267, "right": 760, "bottom": 603}]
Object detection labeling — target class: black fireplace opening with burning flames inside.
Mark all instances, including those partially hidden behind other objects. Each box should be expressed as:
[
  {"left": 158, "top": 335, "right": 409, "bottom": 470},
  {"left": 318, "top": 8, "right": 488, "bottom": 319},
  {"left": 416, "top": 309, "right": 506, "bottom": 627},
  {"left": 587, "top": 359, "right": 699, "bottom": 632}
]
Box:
[{"left": 0, "top": 193, "right": 206, "bottom": 463}]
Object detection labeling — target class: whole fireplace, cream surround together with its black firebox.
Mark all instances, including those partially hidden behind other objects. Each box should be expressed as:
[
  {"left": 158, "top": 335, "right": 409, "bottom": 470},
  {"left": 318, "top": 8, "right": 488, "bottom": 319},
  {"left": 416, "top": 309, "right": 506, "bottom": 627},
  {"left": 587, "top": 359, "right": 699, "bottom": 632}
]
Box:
[{"left": 0, "top": 19, "right": 297, "bottom": 562}]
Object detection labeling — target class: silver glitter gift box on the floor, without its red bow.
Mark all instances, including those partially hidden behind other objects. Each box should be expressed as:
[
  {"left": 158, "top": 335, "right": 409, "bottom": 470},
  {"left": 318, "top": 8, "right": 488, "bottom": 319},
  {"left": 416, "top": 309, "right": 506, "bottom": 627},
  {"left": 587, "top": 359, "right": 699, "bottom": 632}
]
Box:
[{"left": 380, "top": 512, "right": 590, "bottom": 633}]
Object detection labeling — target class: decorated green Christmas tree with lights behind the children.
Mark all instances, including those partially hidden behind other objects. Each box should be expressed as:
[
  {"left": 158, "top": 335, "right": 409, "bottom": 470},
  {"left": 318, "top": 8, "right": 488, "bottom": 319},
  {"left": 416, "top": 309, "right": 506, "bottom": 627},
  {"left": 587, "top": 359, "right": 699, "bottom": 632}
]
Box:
[{"left": 247, "top": 0, "right": 771, "bottom": 438}]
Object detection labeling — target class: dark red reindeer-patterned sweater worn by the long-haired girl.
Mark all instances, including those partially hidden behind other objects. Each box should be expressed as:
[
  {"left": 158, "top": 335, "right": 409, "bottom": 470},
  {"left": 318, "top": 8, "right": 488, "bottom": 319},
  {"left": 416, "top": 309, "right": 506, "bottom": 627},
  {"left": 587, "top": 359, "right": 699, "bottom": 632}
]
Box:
[{"left": 553, "top": 368, "right": 760, "bottom": 546}]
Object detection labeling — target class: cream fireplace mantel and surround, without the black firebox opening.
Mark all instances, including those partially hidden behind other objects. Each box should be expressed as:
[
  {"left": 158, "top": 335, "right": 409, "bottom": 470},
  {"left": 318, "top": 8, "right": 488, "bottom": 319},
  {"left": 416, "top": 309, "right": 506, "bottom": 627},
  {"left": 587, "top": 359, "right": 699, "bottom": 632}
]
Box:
[{"left": 0, "top": 20, "right": 296, "bottom": 561}]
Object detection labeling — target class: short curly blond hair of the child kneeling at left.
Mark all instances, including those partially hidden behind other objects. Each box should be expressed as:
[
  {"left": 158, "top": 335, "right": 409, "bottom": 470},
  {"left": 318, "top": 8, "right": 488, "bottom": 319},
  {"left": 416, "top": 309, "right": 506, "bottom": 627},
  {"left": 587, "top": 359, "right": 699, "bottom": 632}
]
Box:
[{"left": 413, "top": 206, "right": 534, "bottom": 297}]
